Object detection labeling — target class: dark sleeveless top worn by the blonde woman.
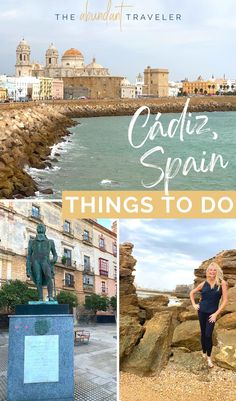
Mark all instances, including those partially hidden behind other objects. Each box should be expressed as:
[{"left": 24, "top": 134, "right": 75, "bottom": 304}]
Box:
[{"left": 199, "top": 281, "right": 222, "bottom": 313}]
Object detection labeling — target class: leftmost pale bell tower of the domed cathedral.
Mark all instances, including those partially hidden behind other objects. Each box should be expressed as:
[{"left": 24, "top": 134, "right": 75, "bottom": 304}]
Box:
[{"left": 16, "top": 39, "right": 32, "bottom": 77}]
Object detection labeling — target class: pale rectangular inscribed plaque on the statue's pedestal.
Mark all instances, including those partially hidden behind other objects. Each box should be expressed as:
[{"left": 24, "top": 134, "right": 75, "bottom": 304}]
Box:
[{"left": 24, "top": 335, "right": 59, "bottom": 383}]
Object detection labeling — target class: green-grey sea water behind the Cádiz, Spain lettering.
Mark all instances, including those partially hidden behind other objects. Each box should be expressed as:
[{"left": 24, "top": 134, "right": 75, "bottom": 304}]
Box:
[{"left": 30, "top": 112, "right": 236, "bottom": 198}]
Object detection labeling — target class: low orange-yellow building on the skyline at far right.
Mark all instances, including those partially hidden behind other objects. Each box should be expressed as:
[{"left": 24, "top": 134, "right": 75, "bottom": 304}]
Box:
[{"left": 183, "top": 76, "right": 218, "bottom": 95}]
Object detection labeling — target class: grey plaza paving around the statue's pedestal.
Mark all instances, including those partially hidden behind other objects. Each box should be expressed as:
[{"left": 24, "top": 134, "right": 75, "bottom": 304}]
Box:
[{"left": 0, "top": 324, "right": 117, "bottom": 401}]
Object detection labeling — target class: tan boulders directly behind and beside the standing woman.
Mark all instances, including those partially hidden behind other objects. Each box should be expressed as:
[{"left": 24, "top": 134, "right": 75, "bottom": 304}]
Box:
[{"left": 172, "top": 250, "right": 236, "bottom": 371}]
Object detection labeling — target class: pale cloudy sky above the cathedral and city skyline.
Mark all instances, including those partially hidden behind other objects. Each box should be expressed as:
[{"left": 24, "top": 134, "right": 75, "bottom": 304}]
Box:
[{"left": 0, "top": 0, "right": 236, "bottom": 81}]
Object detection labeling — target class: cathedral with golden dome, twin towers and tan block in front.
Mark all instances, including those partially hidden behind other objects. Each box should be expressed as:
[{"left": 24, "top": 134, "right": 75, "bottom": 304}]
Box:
[{"left": 16, "top": 39, "right": 123, "bottom": 99}]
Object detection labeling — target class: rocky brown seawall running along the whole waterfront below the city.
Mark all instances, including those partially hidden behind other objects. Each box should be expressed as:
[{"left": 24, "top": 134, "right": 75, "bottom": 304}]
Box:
[{"left": 0, "top": 96, "right": 236, "bottom": 199}]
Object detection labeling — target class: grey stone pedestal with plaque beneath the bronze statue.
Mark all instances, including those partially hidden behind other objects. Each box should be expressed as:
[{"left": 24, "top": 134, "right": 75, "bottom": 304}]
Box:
[{"left": 7, "top": 305, "right": 74, "bottom": 401}]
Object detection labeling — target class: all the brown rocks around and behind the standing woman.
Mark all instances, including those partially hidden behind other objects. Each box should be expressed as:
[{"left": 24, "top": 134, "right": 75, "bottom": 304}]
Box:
[{"left": 120, "top": 243, "right": 236, "bottom": 376}]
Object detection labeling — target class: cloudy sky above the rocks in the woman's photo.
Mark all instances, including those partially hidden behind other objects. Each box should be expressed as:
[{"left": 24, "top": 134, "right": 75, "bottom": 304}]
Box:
[{"left": 120, "top": 219, "right": 236, "bottom": 289}]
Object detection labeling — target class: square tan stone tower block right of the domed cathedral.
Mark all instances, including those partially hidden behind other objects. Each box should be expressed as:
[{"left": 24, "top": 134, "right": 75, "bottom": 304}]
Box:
[{"left": 144, "top": 67, "right": 169, "bottom": 97}]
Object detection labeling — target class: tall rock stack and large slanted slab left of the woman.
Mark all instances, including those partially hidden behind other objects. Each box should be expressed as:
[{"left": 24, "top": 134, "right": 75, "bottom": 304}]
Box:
[{"left": 120, "top": 243, "right": 175, "bottom": 376}]
